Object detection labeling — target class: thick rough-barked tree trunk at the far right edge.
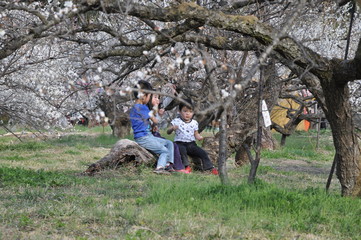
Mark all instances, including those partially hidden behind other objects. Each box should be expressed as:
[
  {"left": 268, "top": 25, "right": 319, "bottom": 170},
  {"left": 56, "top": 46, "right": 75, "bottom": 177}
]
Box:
[{"left": 323, "top": 81, "right": 361, "bottom": 196}]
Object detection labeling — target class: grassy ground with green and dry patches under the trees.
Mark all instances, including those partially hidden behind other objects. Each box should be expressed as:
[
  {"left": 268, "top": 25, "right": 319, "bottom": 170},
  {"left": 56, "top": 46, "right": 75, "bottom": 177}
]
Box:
[{"left": 0, "top": 128, "right": 361, "bottom": 240}]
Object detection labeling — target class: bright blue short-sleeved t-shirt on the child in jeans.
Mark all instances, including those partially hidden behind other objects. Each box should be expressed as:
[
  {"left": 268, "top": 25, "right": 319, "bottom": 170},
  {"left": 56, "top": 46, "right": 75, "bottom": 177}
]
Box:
[{"left": 129, "top": 103, "right": 150, "bottom": 139}]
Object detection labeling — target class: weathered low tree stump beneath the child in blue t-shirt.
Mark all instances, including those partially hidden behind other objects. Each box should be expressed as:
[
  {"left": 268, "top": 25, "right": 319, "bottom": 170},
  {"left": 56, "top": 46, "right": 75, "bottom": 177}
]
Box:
[{"left": 83, "top": 139, "right": 156, "bottom": 175}]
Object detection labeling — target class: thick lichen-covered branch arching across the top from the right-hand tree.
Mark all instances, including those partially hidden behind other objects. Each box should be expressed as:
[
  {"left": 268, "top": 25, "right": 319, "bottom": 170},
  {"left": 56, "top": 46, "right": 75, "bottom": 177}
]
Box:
[{"left": 78, "top": 0, "right": 333, "bottom": 78}]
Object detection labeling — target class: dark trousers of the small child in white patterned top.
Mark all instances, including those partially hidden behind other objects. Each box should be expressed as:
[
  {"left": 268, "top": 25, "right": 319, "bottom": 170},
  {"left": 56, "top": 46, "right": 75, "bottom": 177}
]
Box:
[{"left": 175, "top": 141, "right": 213, "bottom": 170}]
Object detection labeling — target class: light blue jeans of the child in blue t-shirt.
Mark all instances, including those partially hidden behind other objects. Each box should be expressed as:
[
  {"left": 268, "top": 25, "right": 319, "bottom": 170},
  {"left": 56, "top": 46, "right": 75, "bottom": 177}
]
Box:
[{"left": 134, "top": 134, "right": 174, "bottom": 168}]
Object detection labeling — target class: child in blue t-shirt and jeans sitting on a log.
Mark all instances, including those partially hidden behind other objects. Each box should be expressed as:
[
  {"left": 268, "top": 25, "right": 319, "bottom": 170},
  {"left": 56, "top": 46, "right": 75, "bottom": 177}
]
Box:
[{"left": 130, "top": 80, "right": 174, "bottom": 173}]
